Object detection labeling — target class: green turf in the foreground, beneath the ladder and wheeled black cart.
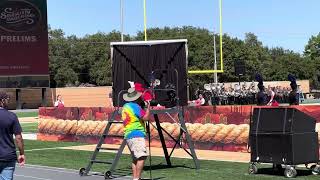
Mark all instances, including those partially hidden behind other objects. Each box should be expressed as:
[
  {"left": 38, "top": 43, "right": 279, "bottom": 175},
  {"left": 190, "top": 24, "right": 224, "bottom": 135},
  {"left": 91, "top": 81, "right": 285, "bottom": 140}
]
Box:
[{"left": 25, "top": 140, "right": 319, "bottom": 180}]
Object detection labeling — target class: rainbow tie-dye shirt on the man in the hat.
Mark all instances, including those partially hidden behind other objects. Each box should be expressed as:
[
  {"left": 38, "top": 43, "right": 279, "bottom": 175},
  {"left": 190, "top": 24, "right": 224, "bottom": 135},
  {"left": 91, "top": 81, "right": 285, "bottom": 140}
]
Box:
[{"left": 121, "top": 102, "right": 146, "bottom": 139}]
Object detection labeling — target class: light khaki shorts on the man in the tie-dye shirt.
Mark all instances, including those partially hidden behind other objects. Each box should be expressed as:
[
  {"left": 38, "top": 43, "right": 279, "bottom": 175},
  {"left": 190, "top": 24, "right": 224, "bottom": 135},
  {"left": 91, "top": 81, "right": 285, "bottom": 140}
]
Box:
[{"left": 126, "top": 137, "right": 148, "bottom": 160}]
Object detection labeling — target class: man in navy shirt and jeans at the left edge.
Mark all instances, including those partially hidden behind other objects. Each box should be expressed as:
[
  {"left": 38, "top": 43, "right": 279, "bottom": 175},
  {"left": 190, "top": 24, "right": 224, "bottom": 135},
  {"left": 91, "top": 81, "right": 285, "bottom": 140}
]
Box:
[{"left": 0, "top": 91, "right": 25, "bottom": 180}]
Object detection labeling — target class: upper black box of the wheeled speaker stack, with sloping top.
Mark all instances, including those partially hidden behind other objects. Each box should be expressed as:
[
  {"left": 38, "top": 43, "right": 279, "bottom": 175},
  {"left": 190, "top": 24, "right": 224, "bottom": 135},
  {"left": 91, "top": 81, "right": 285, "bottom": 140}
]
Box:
[{"left": 250, "top": 107, "right": 316, "bottom": 133}]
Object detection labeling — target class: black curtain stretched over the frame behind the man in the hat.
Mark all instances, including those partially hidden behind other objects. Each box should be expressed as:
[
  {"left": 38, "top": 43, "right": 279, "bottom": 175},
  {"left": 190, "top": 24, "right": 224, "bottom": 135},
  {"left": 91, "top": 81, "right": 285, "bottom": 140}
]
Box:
[{"left": 111, "top": 41, "right": 187, "bottom": 106}]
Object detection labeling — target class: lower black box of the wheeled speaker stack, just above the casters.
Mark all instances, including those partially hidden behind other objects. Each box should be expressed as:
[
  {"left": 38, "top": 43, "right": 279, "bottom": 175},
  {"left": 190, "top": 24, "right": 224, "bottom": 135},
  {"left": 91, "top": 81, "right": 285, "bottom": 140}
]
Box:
[{"left": 249, "top": 132, "right": 319, "bottom": 165}]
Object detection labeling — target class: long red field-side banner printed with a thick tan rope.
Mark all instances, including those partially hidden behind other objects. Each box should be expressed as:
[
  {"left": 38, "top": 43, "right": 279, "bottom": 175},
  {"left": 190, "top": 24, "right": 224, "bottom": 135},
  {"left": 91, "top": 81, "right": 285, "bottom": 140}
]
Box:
[{"left": 38, "top": 105, "right": 320, "bottom": 152}]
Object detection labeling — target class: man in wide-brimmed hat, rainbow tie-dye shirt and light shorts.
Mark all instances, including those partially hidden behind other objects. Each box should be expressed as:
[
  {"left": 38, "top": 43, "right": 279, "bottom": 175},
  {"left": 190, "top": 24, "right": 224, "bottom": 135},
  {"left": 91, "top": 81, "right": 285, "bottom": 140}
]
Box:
[{"left": 121, "top": 88, "right": 150, "bottom": 180}]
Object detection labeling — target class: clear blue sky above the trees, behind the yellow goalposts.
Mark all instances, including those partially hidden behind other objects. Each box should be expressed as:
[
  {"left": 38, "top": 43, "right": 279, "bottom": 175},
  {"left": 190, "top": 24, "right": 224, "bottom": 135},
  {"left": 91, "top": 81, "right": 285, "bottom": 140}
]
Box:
[{"left": 47, "top": 0, "right": 320, "bottom": 53}]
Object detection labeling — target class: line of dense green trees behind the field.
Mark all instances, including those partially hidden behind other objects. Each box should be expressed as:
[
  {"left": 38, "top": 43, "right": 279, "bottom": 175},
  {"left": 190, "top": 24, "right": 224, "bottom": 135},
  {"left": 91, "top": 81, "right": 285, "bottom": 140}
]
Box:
[{"left": 49, "top": 26, "right": 320, "bottom": 88}]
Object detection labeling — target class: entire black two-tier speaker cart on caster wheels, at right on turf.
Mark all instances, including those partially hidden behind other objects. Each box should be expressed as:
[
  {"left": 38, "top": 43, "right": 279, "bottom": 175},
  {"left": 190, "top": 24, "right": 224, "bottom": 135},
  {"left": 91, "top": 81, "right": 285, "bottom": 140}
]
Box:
[{"left": 248, "top": 107, "right": 320, "bottom": 178}]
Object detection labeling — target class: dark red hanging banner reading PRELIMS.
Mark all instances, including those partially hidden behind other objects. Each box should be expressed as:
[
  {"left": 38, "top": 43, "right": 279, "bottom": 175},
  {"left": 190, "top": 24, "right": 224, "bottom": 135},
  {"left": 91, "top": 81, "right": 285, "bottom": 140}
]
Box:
[{"left": 0, "top": 0, "right": 49, "bottom": 88}]
